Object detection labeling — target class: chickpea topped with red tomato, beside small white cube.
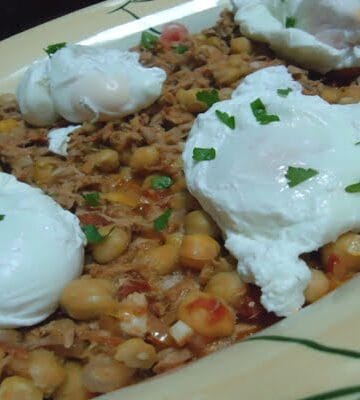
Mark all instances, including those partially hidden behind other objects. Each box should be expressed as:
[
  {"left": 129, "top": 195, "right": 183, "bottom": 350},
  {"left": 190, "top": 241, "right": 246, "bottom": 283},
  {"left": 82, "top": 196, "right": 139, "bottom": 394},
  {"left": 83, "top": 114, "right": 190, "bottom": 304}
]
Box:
[{"left": 177, "top": 292, "right": 235, "bottom": 339}]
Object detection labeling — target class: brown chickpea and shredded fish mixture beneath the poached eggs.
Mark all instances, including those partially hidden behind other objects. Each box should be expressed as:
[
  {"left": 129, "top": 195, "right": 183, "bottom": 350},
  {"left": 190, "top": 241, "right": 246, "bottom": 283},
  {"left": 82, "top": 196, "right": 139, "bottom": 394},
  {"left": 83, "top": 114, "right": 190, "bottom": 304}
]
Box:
[{"left": 0, "top": 7, "right": 360, "bottom": 400}]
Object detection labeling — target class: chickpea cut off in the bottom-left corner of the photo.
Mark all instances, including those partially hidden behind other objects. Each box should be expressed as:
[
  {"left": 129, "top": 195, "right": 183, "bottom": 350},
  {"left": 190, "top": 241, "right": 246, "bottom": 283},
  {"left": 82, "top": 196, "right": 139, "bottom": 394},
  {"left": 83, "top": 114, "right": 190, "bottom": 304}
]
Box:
[{"left": 0, "top": 376, "right": 43, "bottom": 400}]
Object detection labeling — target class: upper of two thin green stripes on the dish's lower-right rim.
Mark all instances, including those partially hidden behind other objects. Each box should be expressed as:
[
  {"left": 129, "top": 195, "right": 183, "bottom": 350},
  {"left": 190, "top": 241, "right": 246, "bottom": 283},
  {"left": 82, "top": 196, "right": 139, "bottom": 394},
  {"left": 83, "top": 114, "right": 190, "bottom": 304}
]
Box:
[{"left": 246, "top": 335, "right": 360, "bottom": 358}]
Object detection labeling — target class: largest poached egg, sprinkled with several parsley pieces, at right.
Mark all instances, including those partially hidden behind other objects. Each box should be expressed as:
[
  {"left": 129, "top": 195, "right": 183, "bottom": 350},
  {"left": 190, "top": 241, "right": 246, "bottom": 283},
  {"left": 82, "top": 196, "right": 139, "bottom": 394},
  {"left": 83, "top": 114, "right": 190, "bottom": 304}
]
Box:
[{"left": 183, "top": 66, "right": 360, "bottom": 316}]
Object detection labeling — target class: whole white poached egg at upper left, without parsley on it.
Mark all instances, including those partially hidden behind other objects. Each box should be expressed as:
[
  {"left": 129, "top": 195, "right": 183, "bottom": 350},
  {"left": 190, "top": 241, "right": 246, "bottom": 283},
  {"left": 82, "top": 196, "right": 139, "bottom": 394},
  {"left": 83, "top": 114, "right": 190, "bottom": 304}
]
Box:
[{"left": 17, "top": 45, "right": 166, "bottom": 126}]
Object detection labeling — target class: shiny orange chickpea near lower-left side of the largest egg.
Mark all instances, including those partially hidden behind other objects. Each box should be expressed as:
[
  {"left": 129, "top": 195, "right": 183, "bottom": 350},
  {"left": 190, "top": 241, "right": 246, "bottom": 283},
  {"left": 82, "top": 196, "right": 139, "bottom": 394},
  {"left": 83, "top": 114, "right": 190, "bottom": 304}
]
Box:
[{"left": 180, "top": 234, "right": 220, "bottom": 270}]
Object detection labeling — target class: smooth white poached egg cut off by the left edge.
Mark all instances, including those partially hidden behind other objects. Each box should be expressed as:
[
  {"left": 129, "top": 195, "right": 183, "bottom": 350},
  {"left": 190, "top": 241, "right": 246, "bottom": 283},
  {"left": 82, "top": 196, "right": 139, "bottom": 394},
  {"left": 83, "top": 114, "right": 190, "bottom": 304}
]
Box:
[{"left": 0, "top": 172, "right": 86, "bottom": 329}]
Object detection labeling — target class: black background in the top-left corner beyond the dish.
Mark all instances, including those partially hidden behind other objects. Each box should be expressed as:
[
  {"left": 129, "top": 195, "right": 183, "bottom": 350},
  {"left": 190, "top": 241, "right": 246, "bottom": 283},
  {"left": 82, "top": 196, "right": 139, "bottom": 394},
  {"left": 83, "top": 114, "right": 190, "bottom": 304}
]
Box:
[{"left": 0, "top": 0, "right": 101, "bottom": 40}]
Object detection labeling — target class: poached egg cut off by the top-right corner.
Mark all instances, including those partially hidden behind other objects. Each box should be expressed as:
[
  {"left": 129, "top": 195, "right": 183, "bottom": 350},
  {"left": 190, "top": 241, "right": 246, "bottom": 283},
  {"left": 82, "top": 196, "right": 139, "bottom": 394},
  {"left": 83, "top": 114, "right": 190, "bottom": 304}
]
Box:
[{"left": 234, "top": 0, "right": 360, "bottom": 73}]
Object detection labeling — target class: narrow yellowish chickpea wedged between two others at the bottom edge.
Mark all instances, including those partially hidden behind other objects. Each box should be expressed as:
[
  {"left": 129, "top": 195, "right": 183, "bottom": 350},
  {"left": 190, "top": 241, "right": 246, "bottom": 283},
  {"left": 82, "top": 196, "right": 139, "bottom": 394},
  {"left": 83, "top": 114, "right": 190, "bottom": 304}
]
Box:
[{"left": 54, "top": 361, "right": 90, "bottom": 400}]
